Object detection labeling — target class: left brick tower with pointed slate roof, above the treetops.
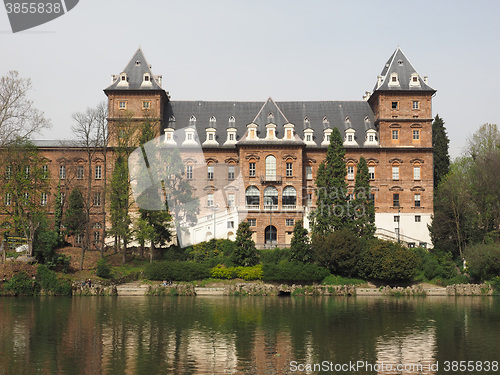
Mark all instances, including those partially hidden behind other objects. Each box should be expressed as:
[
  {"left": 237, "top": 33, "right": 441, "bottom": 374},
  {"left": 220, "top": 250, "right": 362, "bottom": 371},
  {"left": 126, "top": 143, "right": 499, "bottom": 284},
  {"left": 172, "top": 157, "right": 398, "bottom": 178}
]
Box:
[{"left": 104, "top": 48, "right": 169, "bottom": 147}]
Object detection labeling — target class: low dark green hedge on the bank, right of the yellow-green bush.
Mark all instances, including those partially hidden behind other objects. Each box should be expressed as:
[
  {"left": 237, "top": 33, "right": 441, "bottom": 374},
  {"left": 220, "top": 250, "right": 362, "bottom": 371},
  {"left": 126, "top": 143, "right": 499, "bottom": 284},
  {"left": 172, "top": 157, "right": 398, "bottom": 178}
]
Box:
[{"left": 262, "top": 261, "right": 330, "bottom": 282}]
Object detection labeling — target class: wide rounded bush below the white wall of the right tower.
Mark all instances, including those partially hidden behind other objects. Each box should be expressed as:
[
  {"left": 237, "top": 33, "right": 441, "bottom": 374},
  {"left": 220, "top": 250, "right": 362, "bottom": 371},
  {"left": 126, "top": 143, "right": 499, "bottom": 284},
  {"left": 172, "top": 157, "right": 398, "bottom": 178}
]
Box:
[{"left": 360, "top": 239, "right": 420, "bottom": 282}]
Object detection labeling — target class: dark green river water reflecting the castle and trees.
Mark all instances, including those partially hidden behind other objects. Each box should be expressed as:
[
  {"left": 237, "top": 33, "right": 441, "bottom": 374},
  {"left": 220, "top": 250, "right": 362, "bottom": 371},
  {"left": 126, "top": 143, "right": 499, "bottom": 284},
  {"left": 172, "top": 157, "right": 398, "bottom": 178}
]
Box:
[{"left": 0, "top": 297, "right": 500, "bottom": 374}]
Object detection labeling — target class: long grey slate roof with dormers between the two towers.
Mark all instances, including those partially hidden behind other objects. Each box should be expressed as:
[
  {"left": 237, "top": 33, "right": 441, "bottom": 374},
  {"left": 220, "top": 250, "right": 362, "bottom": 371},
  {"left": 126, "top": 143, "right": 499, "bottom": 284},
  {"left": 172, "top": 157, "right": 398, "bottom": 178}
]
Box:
[{"left": 164, "top": 98, "right": 375, "bottom": 146}]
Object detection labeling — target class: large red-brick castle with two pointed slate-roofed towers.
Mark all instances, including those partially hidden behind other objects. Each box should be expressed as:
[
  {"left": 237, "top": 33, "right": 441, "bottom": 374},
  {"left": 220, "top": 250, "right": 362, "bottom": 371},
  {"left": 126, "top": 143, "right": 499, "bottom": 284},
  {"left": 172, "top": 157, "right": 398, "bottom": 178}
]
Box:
[{"left": 11, "top": 48, "right": 436, "bottom": 247}]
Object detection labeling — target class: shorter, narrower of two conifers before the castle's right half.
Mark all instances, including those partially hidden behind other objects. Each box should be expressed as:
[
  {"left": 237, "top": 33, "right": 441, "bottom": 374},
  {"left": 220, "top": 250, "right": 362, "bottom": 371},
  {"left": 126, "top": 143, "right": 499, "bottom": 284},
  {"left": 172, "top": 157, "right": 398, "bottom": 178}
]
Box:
[{"left": 350, "top": 157, "right": 376, "bottom": 237}]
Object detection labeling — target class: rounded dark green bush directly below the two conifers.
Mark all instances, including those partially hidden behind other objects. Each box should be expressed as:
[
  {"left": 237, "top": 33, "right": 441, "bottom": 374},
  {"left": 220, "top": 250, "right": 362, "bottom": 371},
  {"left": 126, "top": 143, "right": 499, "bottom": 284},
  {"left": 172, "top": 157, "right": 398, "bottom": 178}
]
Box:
[{"left": 312, "top": 229, "right": 363, "bottom": 277}]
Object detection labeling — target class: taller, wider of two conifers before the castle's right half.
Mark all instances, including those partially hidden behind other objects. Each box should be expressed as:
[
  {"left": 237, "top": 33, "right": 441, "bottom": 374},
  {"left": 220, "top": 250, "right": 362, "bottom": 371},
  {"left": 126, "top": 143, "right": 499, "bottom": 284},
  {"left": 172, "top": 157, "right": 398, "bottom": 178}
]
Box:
[{"left": 311, "top": 128, "right": 351, "bottom": 235}]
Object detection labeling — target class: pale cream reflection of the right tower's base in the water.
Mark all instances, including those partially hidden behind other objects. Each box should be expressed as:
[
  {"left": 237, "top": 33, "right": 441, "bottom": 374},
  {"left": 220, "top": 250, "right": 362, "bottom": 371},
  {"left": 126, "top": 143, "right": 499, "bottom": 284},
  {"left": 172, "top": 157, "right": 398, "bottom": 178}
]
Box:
[{"left": 376, "top": 327, "right": 437, "bottom": 375}]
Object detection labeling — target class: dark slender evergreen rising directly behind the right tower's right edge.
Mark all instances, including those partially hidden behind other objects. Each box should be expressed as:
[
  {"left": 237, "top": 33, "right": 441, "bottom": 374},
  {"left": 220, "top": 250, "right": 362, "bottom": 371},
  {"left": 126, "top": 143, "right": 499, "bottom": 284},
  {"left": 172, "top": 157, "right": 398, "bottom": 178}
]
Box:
[{"left": 432, "top": 115, "right": 450, "bottom": 189}]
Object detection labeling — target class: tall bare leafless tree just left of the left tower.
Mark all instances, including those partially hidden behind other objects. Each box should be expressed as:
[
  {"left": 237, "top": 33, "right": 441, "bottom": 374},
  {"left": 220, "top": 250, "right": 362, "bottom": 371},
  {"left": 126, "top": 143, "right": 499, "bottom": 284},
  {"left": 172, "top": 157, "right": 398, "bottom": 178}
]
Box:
[{"left": 72, "top": 105, "right": 106, "bottom": 270}]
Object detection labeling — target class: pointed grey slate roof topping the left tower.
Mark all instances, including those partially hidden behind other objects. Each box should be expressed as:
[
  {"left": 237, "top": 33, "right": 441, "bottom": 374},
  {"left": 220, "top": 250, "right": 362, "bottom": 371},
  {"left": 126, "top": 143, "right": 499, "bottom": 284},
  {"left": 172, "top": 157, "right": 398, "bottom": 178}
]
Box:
[{"left": 104, "top": 48, "right": 163, "bottom": 92}]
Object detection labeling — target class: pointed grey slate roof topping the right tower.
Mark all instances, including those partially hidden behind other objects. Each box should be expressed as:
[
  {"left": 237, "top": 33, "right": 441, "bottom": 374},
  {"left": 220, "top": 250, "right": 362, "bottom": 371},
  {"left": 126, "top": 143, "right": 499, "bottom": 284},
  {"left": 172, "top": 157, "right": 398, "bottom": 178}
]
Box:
[{"left": 373, "top": 47, "right": 436, "bottom": 92}]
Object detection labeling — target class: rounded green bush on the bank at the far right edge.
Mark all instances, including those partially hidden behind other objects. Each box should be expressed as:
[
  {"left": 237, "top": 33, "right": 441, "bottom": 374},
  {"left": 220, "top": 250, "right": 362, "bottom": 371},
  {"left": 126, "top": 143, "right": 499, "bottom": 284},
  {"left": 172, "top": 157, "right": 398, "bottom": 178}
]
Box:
[{"left": 464, "top": 244, "right": 500, "bottom": 281}]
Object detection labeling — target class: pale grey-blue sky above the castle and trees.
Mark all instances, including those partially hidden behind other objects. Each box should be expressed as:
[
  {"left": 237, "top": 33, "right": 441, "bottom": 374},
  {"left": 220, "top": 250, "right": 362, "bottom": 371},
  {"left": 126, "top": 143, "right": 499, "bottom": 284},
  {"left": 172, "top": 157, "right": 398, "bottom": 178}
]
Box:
[{"left": 0, "top": 0, "right": 500, "bottom": 157}]
